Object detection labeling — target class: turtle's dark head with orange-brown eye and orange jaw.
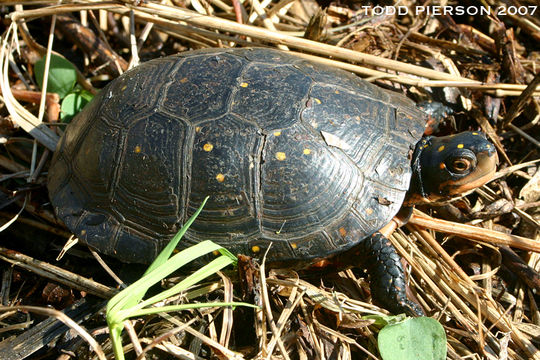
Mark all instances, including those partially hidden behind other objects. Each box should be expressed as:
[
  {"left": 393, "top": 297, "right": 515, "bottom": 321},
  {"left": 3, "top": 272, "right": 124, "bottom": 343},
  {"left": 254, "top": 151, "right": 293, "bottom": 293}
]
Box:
[{"left": 405, "top": 132, "right": 498, "bottom": 205}]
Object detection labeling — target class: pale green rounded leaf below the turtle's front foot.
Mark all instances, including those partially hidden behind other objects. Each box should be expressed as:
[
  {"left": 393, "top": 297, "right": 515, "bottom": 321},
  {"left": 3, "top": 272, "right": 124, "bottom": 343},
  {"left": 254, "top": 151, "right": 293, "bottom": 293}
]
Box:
[{"left": 378, "top": 317, "right": 446, "bottom": 360}]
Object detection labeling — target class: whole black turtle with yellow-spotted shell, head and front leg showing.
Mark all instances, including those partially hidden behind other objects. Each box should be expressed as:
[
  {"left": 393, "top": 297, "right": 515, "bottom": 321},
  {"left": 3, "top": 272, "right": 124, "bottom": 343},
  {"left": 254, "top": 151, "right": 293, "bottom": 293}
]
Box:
[{"left": 48, "top": 48, "right": 497, "bottom": 315}]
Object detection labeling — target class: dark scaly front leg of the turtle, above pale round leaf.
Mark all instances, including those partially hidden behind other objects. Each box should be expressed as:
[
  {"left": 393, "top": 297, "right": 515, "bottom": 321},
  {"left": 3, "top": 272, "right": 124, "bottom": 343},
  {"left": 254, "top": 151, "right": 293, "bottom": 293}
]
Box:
[{"left": 359, "top": 232, "right": 425, "bottom": 316}]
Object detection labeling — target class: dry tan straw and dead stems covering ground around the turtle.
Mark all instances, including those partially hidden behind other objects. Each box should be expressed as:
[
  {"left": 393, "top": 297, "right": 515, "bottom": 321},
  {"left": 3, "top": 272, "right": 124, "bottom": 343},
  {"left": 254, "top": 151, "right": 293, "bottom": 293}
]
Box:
[{"left": 0, "top": 0, "right": 540, "bottom": 359}]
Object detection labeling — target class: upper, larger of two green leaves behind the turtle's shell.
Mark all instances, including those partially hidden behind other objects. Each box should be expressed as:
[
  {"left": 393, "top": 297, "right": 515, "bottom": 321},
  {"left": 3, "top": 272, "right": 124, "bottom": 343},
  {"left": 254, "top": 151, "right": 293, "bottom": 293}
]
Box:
[{"left": 34, "top": 54, "right": 77, "bottom": 99}]
